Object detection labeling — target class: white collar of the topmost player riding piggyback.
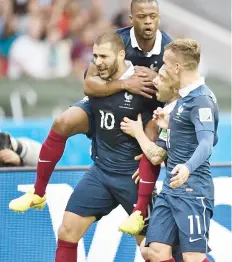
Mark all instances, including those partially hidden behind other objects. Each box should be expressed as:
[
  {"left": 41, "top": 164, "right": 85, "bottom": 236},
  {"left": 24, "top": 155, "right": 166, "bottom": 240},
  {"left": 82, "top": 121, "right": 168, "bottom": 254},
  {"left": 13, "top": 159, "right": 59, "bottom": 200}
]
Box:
[{"left": 130, "top": 27, "right": 162, "bottom": 57}]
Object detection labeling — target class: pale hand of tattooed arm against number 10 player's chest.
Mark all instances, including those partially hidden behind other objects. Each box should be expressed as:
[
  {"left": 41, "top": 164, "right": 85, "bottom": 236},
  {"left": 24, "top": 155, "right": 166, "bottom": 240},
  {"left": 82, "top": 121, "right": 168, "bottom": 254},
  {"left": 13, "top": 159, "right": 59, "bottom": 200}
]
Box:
[{"left": 121, "top": 114, "right": 143, "bottom": 137}]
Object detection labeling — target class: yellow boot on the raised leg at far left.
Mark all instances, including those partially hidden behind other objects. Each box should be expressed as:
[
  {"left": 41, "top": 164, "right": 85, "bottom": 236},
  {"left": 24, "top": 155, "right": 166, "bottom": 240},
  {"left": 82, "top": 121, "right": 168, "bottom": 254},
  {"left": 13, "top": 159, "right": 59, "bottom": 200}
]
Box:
[{"left": 9, "top": 189, "right": 46, "bottom": 212}]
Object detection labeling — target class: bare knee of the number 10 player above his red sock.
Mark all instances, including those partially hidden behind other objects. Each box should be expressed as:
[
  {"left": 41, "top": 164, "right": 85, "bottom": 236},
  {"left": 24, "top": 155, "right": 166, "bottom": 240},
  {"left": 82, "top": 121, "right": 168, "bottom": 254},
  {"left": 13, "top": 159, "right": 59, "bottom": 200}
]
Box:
[{"left": 58, "top": 211, "right": 96, "bottom": 243}]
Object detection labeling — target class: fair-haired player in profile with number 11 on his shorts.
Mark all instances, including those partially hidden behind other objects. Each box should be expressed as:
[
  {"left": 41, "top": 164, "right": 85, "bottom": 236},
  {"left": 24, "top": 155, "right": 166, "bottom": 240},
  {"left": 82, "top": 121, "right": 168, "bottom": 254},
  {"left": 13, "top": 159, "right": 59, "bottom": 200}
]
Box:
[{"left": 121, "top": 39, "right": 219, "bottom": 262}]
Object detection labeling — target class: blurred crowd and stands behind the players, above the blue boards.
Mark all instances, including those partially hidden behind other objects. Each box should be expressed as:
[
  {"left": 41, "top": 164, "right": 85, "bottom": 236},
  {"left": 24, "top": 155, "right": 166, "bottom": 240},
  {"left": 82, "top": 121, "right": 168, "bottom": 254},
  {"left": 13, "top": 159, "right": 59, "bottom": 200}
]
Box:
[{"left": 0, "top": 0, "right": 231, "bottom": 120}]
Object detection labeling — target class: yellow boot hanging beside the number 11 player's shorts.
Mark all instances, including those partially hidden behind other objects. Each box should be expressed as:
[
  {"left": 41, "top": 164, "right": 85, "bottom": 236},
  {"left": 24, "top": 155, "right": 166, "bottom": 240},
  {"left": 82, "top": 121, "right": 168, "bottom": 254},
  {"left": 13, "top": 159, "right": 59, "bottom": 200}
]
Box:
[{"left": 119, "top": 210, "right": 144, "bottom": 236}]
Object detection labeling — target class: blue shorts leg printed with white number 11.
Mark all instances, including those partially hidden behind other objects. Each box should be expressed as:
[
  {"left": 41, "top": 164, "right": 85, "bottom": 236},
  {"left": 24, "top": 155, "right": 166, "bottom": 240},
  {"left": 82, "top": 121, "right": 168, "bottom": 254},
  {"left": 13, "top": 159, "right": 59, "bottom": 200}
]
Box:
[{"left": 169, "top": 196, "right": 213, "bottom": 253}]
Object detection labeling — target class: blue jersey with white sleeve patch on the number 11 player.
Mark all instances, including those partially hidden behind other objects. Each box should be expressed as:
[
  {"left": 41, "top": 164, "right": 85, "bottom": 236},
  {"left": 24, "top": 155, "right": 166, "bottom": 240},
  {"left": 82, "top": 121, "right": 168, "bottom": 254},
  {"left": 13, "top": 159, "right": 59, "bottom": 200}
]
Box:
[{"left": 163, "top": 85, "right": 219, "bottom": 199}]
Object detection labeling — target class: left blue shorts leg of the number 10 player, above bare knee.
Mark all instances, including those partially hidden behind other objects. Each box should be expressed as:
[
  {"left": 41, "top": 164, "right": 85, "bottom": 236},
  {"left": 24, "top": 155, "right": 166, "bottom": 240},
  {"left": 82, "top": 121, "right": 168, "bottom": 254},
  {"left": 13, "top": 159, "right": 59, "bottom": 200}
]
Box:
[{"left": 66, "top": 165, "right": 117, "bottom": 220}]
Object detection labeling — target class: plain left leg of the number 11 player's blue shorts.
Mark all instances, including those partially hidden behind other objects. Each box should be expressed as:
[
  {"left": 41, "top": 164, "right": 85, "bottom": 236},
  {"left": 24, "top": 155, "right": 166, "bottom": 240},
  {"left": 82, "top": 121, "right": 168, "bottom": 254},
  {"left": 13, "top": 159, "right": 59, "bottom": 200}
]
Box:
[{"left": 146, "top": 194, "right": 177, "bottom": 250}]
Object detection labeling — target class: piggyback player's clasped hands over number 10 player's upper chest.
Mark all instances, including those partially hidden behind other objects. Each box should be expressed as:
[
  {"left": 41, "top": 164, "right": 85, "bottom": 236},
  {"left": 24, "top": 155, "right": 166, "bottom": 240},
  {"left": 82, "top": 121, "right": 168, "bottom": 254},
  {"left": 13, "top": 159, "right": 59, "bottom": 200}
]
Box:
[{"left": 124, "top": 75, "right": 156, "bottom": 99}]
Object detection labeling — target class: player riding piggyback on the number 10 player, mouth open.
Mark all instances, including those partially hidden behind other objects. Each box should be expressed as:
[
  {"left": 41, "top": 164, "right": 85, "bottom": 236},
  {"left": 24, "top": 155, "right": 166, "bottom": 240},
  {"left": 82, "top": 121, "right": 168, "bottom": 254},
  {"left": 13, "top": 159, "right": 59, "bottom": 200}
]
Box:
[{"left": 9, "top": 0, "right": 171, "bottom": 217}]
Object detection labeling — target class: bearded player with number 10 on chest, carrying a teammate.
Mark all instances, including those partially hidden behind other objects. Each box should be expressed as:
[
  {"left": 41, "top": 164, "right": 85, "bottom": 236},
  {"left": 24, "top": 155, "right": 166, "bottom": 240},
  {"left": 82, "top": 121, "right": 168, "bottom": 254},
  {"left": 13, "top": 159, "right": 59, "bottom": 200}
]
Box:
[{"left": 56, "top": 33, "right": 161, "bottom": 262}]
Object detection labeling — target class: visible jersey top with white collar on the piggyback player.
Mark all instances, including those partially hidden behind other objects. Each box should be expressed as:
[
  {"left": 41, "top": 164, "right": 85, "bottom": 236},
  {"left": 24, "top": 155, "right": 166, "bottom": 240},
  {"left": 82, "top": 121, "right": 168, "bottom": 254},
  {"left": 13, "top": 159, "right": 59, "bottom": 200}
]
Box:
[{"left": 117, "top": 26, "right": 172, "bottom": 72}]
